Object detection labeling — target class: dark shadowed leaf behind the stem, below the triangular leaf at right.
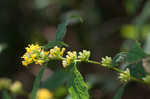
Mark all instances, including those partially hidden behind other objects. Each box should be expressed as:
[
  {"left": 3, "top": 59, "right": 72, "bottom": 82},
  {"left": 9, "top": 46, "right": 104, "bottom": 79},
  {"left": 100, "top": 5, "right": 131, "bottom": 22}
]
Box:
[{"left": 128, "top": 62, "right": 147, "bottom": 79}]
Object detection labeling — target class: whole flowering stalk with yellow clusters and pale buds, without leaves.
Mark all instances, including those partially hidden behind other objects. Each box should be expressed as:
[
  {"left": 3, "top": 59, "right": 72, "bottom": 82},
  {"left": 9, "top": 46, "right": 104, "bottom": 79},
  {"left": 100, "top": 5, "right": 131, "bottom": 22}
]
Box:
[{"left": 22, "top": 44, "right": 148, "bottom": 84}]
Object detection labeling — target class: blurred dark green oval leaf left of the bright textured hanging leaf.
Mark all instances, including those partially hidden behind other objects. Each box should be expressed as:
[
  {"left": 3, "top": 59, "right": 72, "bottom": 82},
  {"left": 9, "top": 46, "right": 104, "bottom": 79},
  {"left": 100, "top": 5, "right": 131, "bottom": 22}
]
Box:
[{"left": 42, "top": 71, "right": 68, "bottom": 90}]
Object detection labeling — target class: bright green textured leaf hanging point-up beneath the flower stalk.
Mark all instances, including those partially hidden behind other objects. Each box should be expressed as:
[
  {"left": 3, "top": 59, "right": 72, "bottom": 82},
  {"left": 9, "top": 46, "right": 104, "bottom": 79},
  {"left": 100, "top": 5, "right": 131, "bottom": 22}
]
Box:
[{"left": 68, "top": 64, "right": 89, "bottom": 99}]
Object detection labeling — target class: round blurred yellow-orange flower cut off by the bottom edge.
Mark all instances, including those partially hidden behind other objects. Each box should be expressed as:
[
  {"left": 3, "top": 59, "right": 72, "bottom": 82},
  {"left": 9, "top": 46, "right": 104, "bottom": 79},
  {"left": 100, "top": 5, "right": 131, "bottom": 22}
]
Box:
[{"left": 37, "top": 88, "right": 53, "bottom": 99}]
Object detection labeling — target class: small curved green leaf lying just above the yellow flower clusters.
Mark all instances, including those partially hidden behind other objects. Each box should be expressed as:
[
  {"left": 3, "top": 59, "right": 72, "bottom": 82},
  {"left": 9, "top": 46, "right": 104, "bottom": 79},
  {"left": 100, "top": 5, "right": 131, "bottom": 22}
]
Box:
[{"left": 44, "top": 41, "right": 68, "bottom": 49}]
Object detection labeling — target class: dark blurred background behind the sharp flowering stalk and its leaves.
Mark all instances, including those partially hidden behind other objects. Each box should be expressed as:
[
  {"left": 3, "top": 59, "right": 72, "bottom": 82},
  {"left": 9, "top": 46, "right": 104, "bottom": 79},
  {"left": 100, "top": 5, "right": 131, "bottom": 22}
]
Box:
[{"left": 0, "top": 0, "right": 150, "bottom": 99}]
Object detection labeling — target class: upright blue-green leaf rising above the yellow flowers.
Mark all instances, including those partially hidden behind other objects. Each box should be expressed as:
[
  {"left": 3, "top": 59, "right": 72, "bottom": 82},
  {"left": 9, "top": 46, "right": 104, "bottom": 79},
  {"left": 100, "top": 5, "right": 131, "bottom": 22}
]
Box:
[{"left": 56, "top": 20, "right": 68, "bottom": 41}]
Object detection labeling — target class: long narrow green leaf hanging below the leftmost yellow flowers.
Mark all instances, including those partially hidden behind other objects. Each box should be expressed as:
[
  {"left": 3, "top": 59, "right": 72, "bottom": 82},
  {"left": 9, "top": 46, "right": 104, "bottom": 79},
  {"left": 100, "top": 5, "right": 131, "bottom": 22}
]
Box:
[{"left": 32, "top": 66, "right": 45, "bottom": 99}]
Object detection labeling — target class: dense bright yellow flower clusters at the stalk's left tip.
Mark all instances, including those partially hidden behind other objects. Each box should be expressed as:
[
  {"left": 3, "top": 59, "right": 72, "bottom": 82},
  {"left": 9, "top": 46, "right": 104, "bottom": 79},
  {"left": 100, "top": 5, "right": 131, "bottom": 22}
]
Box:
[{"left": 22, "top": 44, "right": 65, "bottom": 66}]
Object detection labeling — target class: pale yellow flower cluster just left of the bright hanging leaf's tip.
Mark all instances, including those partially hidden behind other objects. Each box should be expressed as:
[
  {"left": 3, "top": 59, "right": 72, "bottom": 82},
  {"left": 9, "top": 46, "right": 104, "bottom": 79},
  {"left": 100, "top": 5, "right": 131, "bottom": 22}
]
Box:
[{"left": 62, "top": 51, "right": 77, "bottom": 67}]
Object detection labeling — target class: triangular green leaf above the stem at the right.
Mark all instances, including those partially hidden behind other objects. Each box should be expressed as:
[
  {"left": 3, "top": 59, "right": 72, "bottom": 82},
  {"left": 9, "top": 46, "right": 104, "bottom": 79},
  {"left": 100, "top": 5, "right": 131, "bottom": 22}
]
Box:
[{"left": 126, "top": 42, "right": 147, "bottom": 63}]
